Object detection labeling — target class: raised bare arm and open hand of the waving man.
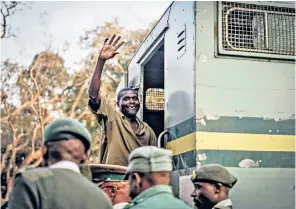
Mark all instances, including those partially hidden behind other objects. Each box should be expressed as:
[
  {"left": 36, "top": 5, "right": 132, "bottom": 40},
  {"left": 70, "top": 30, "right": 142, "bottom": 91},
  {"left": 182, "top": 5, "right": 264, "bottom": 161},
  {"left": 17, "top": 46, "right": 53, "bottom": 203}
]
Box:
[{"left": 88, "top": 35, "right": 124, "bottom": 105}]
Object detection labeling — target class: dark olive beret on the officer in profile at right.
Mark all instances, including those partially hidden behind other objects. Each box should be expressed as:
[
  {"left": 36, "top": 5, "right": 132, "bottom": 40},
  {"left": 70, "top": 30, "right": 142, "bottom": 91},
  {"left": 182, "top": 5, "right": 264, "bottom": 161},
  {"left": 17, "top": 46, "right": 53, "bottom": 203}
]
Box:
[{"left": 191, "top": 164, "right": 237, "bottom": 188}]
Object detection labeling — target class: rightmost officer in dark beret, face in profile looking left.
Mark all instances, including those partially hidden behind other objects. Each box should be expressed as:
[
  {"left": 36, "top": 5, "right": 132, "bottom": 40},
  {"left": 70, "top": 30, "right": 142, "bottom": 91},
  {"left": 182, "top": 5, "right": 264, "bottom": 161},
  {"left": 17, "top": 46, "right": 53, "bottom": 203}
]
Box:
[{"left": 191, "top": 164, "right": 237, "bottom": 209}]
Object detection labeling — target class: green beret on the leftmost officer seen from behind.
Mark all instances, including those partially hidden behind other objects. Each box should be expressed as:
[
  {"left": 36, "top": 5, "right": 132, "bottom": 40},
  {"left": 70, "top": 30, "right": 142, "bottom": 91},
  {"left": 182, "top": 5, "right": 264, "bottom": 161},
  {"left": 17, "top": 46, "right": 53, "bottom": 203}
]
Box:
[{"left": 44, "top": 118, "right": 92, "bottom": 151}]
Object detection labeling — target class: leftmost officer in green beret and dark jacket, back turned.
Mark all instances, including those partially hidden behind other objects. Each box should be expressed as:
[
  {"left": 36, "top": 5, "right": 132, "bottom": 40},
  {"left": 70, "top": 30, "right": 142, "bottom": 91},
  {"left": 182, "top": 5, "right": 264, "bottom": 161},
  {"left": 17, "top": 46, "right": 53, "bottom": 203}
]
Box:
[{"left": 9, "top": 118, "right": 112, "bottom": 209}]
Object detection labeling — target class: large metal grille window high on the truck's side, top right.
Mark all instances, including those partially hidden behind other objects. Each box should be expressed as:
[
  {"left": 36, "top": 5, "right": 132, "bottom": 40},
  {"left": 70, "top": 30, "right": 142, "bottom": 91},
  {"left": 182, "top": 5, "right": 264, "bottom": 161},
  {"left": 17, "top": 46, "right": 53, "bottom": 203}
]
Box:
[{"left": 220, "top": 2, "right": 295, "bottom": 56}]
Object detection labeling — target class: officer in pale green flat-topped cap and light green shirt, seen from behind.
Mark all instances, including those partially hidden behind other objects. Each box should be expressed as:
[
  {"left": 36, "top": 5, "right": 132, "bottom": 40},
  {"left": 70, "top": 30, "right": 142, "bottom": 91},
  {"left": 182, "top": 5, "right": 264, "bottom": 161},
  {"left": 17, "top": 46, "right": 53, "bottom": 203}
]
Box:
[{"left": 125, "top": 146, "right": 190, "bottom": 209}]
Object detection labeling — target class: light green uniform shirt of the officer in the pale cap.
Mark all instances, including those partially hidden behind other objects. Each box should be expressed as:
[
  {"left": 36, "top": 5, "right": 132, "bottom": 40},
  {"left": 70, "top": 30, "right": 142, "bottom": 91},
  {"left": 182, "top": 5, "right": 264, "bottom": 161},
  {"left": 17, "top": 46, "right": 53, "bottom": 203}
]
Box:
[{"left": 124, "top": 185, "right": 191, "bottom": 209}]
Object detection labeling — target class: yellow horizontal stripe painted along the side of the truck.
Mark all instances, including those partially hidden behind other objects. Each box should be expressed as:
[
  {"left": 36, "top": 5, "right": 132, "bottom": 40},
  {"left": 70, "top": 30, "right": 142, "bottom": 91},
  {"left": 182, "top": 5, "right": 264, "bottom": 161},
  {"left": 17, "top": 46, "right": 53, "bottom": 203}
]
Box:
[{"left": 167, "top": 132, "right": 295, "bottom": 155}]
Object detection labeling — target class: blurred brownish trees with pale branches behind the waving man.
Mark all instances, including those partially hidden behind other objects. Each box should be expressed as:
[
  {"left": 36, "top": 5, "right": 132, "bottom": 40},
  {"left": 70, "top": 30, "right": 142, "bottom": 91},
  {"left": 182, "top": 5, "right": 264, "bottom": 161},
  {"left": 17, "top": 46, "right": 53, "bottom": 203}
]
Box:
[{"left": 0, "top": 19, "right": 157, "bottom": 197}]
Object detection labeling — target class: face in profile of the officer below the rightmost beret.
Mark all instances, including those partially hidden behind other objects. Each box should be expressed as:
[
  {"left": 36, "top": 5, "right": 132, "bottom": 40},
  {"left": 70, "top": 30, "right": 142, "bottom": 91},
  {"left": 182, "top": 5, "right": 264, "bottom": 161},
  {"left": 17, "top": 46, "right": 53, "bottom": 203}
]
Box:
[{"left": 191, "top": 182, "right": 217, "bottom": 209}]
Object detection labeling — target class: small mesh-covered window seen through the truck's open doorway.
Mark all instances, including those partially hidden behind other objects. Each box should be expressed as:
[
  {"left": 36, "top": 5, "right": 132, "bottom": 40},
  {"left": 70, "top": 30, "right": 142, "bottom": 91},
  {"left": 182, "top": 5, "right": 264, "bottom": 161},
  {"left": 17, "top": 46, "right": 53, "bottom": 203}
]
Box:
[{"left": 145, "top": 88, "right": 164, "bottom": 111}]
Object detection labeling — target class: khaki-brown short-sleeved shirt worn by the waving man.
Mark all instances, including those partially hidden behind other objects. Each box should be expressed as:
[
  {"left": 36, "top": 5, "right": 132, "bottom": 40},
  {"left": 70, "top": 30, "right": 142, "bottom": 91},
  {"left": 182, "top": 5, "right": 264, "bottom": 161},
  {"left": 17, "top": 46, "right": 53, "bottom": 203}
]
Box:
[{"left": 89, "top": 98, "right": 157, "bottom": 166}]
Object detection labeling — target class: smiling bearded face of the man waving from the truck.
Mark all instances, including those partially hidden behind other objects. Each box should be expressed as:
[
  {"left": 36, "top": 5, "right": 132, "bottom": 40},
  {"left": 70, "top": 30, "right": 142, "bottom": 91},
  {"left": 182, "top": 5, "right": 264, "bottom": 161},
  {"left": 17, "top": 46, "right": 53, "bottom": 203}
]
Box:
[{"left": 118, "top": 90, "right": 140, "bottom": 117}]
